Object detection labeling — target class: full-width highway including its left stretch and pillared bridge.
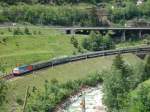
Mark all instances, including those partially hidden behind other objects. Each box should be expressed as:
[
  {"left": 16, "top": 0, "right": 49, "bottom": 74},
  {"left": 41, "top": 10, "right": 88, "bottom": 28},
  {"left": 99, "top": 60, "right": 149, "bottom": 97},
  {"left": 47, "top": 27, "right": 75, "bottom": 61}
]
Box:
[{"left": 0, "top": 26, "right": 150, "bottom": 41}]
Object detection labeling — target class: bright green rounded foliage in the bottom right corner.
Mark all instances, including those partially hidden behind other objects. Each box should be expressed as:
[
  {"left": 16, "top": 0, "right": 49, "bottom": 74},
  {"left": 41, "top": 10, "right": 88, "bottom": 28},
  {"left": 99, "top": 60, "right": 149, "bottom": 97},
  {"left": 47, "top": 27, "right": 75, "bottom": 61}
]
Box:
[{"left": 126, "top": 81, "right": 150, "bottom": 112}]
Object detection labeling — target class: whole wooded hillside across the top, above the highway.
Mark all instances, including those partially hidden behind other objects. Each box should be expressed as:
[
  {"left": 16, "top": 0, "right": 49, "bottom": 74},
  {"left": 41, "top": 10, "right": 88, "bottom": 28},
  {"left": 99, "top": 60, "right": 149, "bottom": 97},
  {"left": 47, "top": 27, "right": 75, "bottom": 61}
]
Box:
[{"left": 0, "top": 0, "right": 150, "bottom": 26}]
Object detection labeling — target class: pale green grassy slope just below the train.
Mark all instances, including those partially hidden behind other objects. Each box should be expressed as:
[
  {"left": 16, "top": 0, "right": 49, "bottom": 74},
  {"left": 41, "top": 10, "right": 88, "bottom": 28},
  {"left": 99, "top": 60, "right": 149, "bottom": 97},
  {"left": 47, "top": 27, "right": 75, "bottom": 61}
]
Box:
[{"left": 1, "top": 54, "right": 140, "bottom": 112}]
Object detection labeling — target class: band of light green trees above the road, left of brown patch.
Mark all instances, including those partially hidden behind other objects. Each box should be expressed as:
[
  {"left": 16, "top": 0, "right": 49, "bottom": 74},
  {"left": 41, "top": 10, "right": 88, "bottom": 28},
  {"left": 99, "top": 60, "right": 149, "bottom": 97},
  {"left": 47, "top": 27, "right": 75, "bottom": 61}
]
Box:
[{"left": 1, "top": 4, "right": 95, "bottom": 26}]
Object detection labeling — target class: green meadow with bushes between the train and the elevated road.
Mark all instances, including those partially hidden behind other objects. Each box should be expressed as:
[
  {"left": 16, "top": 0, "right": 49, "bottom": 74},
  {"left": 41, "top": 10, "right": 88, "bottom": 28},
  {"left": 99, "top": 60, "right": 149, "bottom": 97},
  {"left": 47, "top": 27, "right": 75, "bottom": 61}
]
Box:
[{"left": 0, "top": 26, "right": 146, "bottom": 72}]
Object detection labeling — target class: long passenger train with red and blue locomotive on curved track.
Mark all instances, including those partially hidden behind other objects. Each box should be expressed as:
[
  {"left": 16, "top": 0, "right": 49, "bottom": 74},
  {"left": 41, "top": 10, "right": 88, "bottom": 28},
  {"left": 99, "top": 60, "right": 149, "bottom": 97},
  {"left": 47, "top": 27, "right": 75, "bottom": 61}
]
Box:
[{"left": 12, "top": 47, "right": 150, "bottom": 76}]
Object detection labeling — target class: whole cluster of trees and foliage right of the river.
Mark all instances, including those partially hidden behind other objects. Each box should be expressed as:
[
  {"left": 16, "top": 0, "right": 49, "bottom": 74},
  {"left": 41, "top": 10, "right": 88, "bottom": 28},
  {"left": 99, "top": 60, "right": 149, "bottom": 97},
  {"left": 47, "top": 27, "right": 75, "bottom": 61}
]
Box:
[{"left": 104, "top": 55, "right": 150, "bottom": 112}]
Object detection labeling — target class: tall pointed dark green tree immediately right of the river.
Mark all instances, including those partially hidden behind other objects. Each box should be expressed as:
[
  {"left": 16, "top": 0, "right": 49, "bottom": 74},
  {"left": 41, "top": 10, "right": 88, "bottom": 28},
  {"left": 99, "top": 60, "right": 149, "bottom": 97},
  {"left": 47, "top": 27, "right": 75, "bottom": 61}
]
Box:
[{"left": 104, "top": 55, "right": 132, "bottom": 112}]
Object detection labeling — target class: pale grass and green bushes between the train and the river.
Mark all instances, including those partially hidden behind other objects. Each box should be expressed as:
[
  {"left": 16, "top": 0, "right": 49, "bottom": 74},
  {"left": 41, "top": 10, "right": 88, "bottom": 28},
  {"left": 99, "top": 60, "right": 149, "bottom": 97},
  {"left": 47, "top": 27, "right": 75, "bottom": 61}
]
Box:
[{"left": 1, "top": 55, "right": 141, "bottom": 111}]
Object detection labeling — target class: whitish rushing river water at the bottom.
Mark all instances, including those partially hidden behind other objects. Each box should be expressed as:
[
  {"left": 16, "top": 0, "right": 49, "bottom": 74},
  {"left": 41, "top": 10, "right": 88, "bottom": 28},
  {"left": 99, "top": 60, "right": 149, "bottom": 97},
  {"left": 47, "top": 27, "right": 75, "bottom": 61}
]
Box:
[{"left": 57, "top": 86, "right": 106, "bottom": 112}]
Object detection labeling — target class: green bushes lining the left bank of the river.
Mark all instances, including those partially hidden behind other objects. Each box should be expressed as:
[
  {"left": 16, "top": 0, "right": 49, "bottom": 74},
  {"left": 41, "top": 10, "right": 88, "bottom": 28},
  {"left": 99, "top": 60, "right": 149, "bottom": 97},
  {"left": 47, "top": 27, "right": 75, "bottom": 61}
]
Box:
[{"left": 27, "top": 74, "right": 102, "bottom": 112}]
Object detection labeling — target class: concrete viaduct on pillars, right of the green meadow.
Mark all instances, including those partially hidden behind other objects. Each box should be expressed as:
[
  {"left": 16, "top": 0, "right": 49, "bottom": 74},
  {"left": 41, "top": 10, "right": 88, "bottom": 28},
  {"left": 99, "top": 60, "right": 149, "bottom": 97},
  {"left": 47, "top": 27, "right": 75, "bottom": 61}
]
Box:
[{"left": 56, "top": 27, "right": 150, "bottom": 41}]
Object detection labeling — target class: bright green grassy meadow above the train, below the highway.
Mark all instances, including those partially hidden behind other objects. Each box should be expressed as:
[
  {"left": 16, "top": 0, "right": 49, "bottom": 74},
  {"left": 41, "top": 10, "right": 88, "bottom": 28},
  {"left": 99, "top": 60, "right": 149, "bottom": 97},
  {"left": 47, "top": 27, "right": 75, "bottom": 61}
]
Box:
[{"left": 0, "top": 28, "right": 86, "bottom": 71}]
